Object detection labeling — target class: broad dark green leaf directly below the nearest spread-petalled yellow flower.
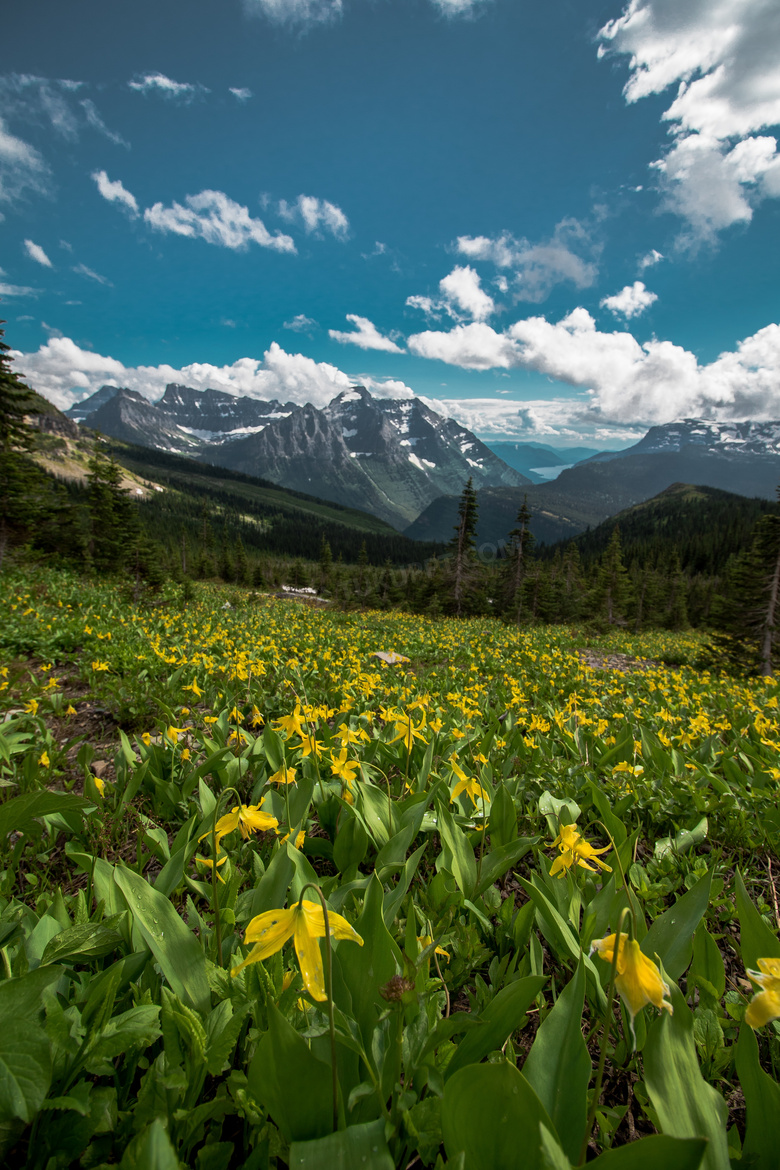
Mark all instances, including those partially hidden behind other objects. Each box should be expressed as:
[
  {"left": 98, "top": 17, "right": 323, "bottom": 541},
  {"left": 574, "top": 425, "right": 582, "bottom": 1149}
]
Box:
[{"left": 248, "top": 1003, "right": 333, "bottom": 1142}]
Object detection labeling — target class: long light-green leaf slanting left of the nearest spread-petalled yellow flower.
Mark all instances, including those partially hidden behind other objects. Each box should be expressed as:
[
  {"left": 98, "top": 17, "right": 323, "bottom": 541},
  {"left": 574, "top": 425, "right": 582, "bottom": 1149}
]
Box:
[{"left": 113, "top": 866, "right": 212, "bottom": 1014}]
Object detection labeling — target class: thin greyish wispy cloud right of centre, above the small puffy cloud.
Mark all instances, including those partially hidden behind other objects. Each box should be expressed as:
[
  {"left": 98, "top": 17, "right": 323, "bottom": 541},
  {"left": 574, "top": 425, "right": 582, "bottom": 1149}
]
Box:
[{"left": 456, "top": 216, "right": 600, "bottom": 304}]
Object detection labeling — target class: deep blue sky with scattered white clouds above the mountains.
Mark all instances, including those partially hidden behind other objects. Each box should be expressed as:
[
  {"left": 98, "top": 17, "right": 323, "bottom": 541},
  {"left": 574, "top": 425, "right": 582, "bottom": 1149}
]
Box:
[{"left": 0, "top": 0, "right": 780, "bottom": 446}]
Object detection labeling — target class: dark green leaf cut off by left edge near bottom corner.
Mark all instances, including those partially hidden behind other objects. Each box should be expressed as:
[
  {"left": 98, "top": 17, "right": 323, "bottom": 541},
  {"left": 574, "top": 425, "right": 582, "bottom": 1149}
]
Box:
[{"left": 0, "top": 966, "right": 62, "bottom": 1124}]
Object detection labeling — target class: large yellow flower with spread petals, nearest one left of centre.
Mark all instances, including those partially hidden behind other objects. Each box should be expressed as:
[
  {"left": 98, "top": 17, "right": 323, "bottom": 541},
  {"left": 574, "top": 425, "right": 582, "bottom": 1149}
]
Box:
[{"left": 230, "top": 902, "right": 363, "bottom": 1002}]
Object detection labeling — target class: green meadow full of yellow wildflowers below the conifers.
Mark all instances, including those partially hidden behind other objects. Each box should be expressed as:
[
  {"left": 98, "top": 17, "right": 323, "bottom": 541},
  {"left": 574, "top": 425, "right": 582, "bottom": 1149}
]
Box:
[{"left": 0, "top": 569, "right": 780, "bottom": 1170}]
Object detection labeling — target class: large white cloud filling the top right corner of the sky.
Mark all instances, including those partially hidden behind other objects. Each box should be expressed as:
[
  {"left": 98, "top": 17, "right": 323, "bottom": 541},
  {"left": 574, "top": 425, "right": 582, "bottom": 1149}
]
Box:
[{"left": 599, "top": 0, "right": 780, "bottom": 243}]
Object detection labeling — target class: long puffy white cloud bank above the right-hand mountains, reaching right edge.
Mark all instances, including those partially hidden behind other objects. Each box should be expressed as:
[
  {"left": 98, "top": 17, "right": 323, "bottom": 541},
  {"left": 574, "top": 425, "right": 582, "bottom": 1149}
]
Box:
[{"left": 408, "top": 308, "right": 780, "bottom": 424}]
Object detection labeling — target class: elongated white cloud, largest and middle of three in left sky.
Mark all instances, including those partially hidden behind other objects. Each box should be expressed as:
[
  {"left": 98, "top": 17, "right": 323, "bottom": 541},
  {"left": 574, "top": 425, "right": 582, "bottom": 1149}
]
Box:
[{"left": 144, "top": 191, "right": 296, "bottom": 252}]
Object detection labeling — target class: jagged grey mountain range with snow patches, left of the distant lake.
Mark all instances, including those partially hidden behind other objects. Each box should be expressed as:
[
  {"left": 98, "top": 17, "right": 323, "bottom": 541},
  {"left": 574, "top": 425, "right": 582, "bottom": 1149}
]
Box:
[{"left": 68, "top": 383, "right": 531, "bottom": 528}]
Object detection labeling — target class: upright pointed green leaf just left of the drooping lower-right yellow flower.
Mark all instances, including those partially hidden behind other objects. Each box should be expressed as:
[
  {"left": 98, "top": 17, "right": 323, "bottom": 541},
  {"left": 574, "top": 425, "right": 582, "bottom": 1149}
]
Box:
[{"left": 523, "top": 962, "right": 592, "bottom": 1162}]
